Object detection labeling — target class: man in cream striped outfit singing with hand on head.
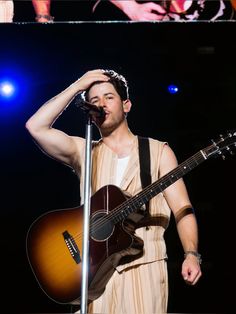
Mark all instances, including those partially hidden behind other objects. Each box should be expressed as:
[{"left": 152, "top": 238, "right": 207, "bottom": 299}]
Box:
[{"left": 26, "top": 69, "right": 201, "bottom": 314}]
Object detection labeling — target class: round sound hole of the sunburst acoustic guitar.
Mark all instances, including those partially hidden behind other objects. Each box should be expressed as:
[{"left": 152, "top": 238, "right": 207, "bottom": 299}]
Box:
[{"left": 90, "top": 212, "right": 115, "bottom": 241}]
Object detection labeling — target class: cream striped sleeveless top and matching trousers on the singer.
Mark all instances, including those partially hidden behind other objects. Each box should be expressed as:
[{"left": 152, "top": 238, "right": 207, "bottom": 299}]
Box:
[{"left": 74, "top": 137, "right": 171, "bottom": 314}]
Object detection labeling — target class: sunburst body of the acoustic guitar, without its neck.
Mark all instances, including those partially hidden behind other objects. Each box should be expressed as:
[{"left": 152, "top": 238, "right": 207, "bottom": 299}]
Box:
[{"left": 27, "top": 185, "right": 143, "bottom": 304}]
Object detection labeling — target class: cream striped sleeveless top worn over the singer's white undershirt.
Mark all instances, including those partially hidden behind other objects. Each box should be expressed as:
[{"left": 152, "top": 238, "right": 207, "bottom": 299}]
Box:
[{"left": 75, "top": 136, "right": 171, "bottom": 271}]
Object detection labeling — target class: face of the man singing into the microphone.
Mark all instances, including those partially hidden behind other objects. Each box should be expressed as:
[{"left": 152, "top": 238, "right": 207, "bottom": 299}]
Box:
[{"left": 88, "top": 82, "right": 129, "bottom": 132}]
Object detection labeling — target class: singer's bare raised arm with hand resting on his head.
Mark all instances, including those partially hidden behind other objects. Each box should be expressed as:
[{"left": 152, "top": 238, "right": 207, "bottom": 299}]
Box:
[{"left": 26, "top": 70, "right": 108, "bottom": 165}]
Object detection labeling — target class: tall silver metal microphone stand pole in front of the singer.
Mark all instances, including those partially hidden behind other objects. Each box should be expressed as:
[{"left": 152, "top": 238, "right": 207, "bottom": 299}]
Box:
[{"left": 80, "top": 111, "right": 92, "bottom": 314}]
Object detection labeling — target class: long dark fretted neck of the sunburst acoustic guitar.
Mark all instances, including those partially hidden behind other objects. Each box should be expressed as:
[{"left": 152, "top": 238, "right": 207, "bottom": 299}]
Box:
[{"left": 110, "top": 150, "right": 207, "bottom": 224}]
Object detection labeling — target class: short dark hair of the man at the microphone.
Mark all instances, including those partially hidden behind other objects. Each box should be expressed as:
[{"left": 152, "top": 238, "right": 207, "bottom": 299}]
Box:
[{"left": 82, "top": 70, "right": 129, "bottom": 101}]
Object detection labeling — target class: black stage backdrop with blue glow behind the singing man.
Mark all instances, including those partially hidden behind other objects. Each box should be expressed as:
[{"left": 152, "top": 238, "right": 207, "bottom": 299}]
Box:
[{"left": 0, "top": 22, "right": 236, "bottom": 313}]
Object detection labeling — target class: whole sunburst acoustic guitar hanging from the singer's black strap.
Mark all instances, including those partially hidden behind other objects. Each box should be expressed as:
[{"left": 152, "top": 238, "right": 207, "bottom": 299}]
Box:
[{"left": 26, "top": 131, "right": 236, "bottom": 304}]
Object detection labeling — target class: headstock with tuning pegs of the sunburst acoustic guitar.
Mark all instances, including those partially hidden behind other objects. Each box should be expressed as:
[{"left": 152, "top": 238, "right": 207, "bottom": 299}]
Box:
[{"left": 202, "top": 130, "right": 236, "bottom": 159}]
